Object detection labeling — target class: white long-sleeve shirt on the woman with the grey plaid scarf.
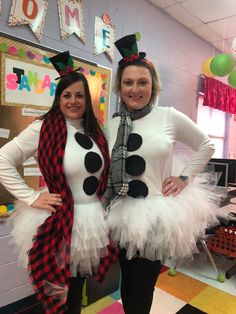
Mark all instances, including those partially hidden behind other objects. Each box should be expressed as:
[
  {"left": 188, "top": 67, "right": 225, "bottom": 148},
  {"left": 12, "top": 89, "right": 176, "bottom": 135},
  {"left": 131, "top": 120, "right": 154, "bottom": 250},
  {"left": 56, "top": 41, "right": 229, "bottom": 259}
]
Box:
[{"left": 106, "top": 107, "right": 214, "bottom": 196}]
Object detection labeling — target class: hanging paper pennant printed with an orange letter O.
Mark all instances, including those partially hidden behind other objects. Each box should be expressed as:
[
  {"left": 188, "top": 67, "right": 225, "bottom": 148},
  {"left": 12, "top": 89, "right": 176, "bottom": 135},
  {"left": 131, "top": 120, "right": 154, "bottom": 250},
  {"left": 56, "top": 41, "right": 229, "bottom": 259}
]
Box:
[{"left": 8, "top": 0, "right": 48, "bottom": 40}]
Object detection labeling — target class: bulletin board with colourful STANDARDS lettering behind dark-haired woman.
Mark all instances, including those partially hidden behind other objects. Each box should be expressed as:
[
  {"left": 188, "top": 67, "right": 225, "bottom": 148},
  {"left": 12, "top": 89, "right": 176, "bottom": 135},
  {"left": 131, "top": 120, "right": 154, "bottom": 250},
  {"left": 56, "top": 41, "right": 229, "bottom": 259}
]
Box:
[{"left": 0, "top": 34, "right": 111, "bottom": 204}]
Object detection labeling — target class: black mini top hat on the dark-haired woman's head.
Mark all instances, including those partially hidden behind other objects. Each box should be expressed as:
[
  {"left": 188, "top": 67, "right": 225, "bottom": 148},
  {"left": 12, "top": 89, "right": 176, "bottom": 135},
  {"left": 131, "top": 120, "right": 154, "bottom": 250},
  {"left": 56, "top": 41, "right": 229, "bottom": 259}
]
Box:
[{"left": 49, "top": 51, "right": 78, "bottom": 80}]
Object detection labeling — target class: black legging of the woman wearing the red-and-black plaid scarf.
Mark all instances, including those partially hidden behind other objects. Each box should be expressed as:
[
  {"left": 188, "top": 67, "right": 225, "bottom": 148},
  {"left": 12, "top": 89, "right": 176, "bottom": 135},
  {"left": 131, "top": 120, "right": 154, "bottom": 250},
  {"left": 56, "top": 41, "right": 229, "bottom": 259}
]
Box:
[{"left": 66, "top": 274, "right": 85, "bottom": 314}]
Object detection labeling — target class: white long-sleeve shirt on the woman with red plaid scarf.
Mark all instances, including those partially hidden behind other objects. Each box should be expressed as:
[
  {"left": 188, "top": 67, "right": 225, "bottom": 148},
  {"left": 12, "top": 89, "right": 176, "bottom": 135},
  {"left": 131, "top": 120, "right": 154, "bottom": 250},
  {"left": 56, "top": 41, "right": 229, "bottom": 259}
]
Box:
[{"left": 0, "top": 119, "right": 104, "bottom": 205}]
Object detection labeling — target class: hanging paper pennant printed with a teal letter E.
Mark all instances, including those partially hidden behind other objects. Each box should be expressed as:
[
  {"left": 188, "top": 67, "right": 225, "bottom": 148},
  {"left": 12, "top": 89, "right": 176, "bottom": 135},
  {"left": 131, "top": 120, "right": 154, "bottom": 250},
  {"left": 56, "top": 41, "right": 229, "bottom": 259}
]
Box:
[{"left": 94, "top": 14, "right": 115, "bottom": 62}]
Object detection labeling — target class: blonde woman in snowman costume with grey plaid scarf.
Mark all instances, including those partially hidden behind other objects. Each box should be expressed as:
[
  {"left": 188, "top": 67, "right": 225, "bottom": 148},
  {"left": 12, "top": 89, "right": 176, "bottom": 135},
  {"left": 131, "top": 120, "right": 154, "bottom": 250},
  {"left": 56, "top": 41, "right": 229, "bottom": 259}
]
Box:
[{"left": 105, "top": 34, "right": 219, "bottom": 314}]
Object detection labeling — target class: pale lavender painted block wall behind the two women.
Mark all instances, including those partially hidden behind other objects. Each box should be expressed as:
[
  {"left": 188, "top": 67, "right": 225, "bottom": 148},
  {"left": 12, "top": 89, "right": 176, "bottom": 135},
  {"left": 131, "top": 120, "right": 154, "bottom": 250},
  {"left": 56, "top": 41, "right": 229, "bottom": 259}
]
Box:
[{"left": 0, "top": 0, "right": 218, "bottom": 307}]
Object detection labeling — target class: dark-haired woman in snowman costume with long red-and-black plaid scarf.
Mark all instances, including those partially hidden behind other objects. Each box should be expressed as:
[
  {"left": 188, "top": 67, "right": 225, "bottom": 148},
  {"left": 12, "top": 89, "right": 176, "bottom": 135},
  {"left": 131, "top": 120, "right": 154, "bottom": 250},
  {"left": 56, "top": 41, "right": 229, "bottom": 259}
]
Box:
[{"left": 0, "top": 51, "right": 117, "bottom": 314}]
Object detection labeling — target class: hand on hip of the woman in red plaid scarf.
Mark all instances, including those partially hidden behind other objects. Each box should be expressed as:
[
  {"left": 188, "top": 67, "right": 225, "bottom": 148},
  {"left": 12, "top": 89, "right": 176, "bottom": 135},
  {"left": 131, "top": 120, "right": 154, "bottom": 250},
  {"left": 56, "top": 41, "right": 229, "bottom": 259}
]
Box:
[{"left": 31, "top": 191, "right": 62, "bottom": 213}]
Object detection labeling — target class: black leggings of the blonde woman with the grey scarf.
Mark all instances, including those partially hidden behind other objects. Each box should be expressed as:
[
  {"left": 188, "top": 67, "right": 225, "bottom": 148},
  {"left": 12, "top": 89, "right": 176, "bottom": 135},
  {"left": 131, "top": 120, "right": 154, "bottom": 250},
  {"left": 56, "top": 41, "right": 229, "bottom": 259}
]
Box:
[{"left": 120, "top": 249, "right": 162, "bottom": 314}]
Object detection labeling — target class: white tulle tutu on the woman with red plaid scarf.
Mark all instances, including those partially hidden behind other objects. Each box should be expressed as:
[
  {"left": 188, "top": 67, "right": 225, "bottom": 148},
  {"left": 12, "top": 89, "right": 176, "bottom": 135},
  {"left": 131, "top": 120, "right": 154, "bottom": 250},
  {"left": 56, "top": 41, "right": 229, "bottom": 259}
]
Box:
[{"left": 10, "top": 201, "right": 109, "bottom": 276}]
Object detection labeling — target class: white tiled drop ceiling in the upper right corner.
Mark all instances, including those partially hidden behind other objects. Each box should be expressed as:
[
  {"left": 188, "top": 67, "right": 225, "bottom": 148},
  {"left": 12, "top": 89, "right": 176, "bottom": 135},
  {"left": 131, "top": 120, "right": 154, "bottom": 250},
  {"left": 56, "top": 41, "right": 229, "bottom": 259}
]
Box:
[{"left": 146, "top": 0, "right": 236, "bottom": 53}]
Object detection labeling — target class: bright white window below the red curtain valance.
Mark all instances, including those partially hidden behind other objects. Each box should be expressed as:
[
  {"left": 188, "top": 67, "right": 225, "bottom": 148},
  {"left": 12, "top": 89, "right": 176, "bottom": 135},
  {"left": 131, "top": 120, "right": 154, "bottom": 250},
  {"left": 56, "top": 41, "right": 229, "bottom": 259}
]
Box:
[{"left": 197, "top": 95, "right": 226, "bottom": 158}]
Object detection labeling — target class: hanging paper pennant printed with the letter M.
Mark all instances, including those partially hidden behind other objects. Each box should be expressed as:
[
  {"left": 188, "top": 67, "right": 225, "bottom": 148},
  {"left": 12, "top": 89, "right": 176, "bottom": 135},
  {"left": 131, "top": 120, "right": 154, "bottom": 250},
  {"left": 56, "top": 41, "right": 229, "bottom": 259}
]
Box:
[{"left": 57, "top": 0, "right": 85, "bottom": 43}]
